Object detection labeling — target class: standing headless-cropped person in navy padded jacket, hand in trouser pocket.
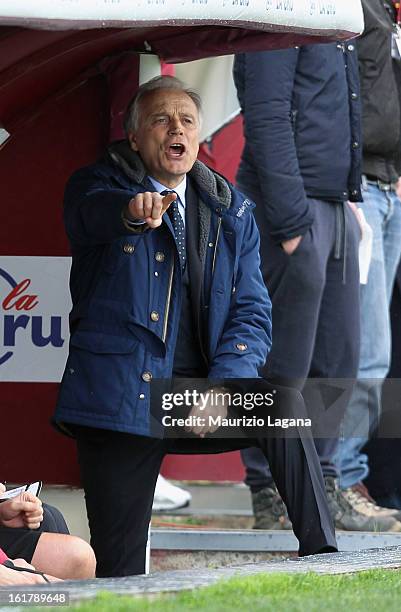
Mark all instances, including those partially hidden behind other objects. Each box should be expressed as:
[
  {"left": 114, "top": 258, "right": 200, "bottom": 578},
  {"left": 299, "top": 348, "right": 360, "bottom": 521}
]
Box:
[{"left": 234, "top": 41, "right": 401, "bottom": 531}]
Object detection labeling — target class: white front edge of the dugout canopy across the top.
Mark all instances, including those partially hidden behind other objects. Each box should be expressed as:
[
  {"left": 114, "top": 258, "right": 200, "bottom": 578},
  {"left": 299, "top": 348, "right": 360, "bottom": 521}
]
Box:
[{"left": 0, "top": 0, "right": 363, "bottom": 38}]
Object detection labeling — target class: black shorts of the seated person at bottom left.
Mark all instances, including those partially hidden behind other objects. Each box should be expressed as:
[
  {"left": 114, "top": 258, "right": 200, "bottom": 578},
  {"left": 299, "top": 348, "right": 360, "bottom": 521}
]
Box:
[{"left": 0, "top": 504, "right": 69, "bottom": 563}]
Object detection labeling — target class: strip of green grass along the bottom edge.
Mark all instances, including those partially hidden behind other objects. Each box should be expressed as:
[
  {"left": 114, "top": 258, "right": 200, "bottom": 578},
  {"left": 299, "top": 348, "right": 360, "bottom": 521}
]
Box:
[{"left": 54, "top": 570, "right": 401, "bottom": 612}]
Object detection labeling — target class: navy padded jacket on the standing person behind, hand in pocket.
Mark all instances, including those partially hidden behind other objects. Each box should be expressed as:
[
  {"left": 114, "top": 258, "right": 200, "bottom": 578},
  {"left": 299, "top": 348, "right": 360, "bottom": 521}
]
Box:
[{"left": 234, "top": 42, "right": 362, "bottom": 243}]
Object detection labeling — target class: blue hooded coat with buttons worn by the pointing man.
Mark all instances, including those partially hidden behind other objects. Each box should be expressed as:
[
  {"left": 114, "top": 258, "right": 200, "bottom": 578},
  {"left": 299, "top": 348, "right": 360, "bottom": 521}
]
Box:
[{"left": 55, "top": 143, "right": 271, "bottom": 435}]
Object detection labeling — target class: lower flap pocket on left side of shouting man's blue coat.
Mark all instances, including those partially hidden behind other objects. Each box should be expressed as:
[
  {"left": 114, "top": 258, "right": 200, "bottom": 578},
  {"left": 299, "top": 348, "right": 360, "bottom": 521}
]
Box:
[{"left": 59, "top": 330, "right": 141, "bottom": 424}]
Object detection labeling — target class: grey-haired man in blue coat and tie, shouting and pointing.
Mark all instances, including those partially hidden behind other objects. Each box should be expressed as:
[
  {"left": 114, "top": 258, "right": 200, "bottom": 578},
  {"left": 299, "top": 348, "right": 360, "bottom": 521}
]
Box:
[{"left": 55, "top": 77, "right": 336, "bottom": 576}]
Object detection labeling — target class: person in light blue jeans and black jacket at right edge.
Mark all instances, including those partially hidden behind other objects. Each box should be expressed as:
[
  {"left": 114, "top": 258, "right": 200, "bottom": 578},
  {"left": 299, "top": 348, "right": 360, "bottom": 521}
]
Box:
[{"left": 336, "top": 0, "right": 401, "bottom": 519}]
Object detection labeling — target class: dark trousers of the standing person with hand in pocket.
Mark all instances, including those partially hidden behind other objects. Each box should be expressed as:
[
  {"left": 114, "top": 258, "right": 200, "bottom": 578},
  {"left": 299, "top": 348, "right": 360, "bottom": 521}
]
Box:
[{"left": 240, "top": 196, "right": 360, "bottom": 488}]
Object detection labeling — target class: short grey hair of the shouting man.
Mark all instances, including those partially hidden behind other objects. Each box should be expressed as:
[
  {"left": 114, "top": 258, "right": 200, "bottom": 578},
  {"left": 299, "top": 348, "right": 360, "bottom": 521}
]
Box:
[{"left": 124, "top": 76, "right": 202, "bottom": 136}]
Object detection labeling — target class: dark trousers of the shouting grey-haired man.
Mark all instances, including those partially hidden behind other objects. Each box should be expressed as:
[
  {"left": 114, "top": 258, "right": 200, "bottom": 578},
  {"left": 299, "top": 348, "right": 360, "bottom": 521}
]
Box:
[{"left": 75, "top": 402, "right": 336, "bottom": 577}]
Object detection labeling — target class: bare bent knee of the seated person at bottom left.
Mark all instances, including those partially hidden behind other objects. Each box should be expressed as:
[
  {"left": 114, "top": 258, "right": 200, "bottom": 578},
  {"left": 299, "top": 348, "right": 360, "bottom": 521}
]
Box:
[{"left": 31, "top": 533, "right": 96, "bottom": 580}]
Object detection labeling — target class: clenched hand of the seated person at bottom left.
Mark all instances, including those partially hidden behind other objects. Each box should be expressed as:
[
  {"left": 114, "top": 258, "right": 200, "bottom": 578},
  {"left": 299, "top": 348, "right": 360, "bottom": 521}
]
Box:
[{"left": 0, "top": 492, "right": 43, "bottom": 529}]
